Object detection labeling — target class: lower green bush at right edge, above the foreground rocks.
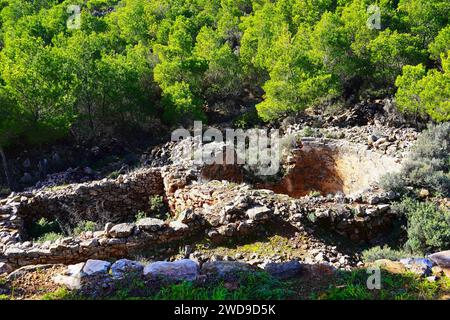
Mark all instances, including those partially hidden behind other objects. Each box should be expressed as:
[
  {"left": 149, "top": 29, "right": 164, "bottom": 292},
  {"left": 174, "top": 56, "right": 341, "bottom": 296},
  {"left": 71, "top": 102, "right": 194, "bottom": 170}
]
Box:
[{"left": 396, "top": 198, "right": 450, "bottom": 253}]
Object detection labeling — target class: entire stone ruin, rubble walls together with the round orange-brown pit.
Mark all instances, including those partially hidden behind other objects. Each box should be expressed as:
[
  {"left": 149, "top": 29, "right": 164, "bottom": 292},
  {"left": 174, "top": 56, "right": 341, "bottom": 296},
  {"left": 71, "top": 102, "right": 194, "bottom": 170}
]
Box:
[{"left": 0, "top": 131, "right": 412, "bottom": 270}]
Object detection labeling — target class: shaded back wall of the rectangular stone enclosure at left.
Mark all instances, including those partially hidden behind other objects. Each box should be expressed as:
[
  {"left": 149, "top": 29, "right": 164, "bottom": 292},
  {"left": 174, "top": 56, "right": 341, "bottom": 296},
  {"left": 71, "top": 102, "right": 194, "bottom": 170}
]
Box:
[{"left": 0, "top": 168, "right": 164, "bottom": 230}]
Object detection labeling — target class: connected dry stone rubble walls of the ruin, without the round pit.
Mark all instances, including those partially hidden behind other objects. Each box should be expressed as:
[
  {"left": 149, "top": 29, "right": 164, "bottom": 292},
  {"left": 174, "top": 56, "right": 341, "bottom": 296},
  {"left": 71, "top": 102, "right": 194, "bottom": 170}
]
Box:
[{"left": 0, "top": 136, "right": 408, "bottom": 268}]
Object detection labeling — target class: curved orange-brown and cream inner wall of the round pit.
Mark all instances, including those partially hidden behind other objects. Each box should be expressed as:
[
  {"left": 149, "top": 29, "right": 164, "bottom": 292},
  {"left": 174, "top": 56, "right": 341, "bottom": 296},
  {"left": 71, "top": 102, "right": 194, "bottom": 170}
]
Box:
[{"left": 259, "top": 138, "right": 400, "bottom": 198}]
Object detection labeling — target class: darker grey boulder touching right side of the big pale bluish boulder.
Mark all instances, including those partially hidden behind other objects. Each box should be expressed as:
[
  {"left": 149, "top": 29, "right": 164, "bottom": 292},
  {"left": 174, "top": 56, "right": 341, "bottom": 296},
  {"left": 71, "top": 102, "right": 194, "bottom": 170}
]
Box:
[{"left": 201, "top": 261, "right": 255, "bottom": 280}]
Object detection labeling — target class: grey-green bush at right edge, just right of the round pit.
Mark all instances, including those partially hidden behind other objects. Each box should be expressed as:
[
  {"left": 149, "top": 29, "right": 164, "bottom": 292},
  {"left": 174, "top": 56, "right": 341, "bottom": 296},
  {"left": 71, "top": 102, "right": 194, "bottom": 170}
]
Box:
[{"left": 380, "top": 123, "right": 450, "bottom": 197}]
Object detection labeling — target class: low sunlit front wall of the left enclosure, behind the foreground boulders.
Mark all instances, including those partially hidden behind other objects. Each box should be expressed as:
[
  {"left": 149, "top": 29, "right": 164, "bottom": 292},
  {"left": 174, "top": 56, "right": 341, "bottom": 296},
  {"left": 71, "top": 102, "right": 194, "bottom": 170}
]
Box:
[{"left": 0, "top": 217, "right": 202, "bottom": 269}]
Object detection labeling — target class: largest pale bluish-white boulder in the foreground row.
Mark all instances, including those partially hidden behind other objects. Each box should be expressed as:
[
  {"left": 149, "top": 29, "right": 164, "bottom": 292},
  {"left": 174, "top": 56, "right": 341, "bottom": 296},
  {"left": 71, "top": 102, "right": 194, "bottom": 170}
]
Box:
[{"left": 144, "top": 259, "right": 199, "bottom": 281}]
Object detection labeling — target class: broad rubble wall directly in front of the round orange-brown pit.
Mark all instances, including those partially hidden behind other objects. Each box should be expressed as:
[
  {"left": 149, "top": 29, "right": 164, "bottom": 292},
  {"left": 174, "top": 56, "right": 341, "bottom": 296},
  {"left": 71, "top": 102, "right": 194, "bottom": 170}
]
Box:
[{"left": 170, "top": 181, "right": 399, "bottom": 242}]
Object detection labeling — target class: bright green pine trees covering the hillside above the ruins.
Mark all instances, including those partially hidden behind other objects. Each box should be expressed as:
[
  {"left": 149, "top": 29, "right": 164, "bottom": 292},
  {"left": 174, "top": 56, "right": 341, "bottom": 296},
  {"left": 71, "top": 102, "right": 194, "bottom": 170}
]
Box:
[{"left": 0, "top": 0, "right": 450, "bottom": 146}]
